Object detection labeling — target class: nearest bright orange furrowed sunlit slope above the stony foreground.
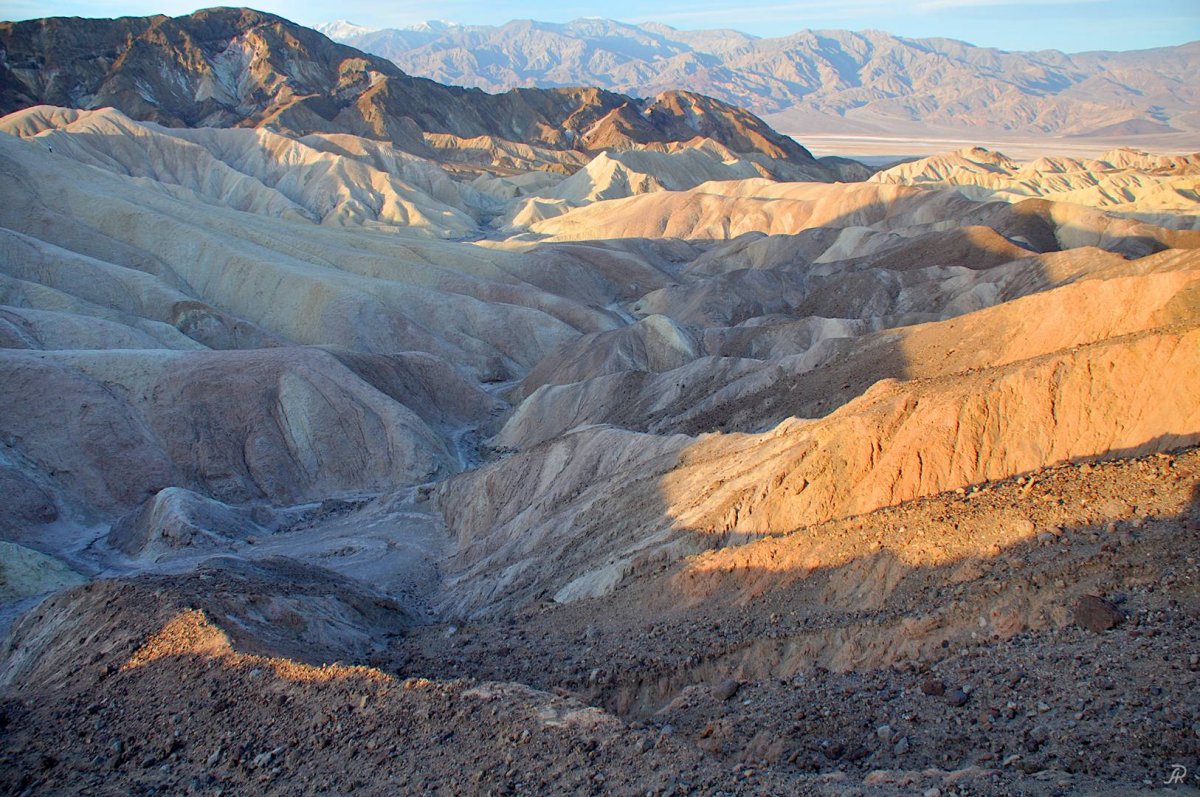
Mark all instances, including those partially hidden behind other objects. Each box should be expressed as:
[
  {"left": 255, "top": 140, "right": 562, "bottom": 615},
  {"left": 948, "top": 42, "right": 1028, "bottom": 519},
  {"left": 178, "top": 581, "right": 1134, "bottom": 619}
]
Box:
[{"left": 662, "top": 330, "right": 1200, "bottom": 542}]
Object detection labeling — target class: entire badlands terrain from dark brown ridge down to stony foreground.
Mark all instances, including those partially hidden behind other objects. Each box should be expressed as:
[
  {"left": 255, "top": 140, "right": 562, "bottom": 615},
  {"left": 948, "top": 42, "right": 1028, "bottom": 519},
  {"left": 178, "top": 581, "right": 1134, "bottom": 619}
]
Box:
[{"left": 0, "top": 10, "right": 1200, "bottom": 797}]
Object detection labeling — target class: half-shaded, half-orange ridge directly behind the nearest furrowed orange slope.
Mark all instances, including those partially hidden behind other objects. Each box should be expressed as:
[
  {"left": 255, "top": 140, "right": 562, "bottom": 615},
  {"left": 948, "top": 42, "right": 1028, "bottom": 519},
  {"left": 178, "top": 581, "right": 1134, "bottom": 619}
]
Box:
[{"left": 494, "top": 251, "right": 1200, "bottom": 448}]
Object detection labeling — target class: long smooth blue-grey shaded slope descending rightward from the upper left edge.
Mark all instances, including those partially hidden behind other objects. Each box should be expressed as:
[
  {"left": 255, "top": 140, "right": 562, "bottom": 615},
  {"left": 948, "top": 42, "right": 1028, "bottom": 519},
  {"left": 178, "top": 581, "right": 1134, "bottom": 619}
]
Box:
[{"left": 0, "top": 137, "right": 612, "bottom": 376}]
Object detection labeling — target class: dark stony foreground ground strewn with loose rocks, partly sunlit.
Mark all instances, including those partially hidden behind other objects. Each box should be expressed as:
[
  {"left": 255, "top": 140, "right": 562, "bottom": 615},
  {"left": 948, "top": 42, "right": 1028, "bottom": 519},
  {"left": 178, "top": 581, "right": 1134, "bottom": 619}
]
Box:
[{"left": 0, "top": 449, "right": 1200, "bottom": 797}]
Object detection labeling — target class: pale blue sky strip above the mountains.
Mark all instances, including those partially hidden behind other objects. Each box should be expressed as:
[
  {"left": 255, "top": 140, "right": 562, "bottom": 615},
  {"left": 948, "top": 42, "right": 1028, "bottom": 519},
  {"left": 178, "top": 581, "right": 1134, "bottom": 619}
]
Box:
[{"left": 0, "top": 0, "right": 1200, "bottom": 53}]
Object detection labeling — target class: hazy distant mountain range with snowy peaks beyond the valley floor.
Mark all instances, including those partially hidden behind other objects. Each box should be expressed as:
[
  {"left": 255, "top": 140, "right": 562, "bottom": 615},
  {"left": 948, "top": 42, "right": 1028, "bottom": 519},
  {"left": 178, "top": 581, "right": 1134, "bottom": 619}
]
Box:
[{"left": 324, "top": 19, "right": 1200, "bottom": 136}]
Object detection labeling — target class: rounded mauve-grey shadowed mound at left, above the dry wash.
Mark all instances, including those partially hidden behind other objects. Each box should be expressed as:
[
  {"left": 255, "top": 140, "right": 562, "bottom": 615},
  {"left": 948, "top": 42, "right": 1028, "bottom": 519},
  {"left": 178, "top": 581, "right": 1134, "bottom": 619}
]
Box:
[{"left": 0, "top": 348, "right": 457, "bottom": 513}]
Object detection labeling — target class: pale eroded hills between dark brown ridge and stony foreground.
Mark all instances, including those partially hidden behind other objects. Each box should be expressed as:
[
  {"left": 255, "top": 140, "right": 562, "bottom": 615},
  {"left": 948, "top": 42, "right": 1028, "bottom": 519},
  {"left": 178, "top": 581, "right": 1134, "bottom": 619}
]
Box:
[{"left": 0, "top": 91, "right": 1200, "bottom": 691}]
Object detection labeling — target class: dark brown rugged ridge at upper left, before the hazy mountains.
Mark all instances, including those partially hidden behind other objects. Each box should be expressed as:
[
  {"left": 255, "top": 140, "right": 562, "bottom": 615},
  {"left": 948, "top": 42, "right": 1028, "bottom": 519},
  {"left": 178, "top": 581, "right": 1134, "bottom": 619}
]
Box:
[{"left": 0, "top": 8, "right": 832, "bottom": 179}]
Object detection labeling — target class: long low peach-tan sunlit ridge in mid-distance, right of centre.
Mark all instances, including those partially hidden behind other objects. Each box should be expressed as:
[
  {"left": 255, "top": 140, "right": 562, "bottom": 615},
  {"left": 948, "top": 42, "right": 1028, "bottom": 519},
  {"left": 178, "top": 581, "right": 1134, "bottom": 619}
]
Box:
[{"left": 529, "top": 179, "right": 1200, "bottom": 259}]
